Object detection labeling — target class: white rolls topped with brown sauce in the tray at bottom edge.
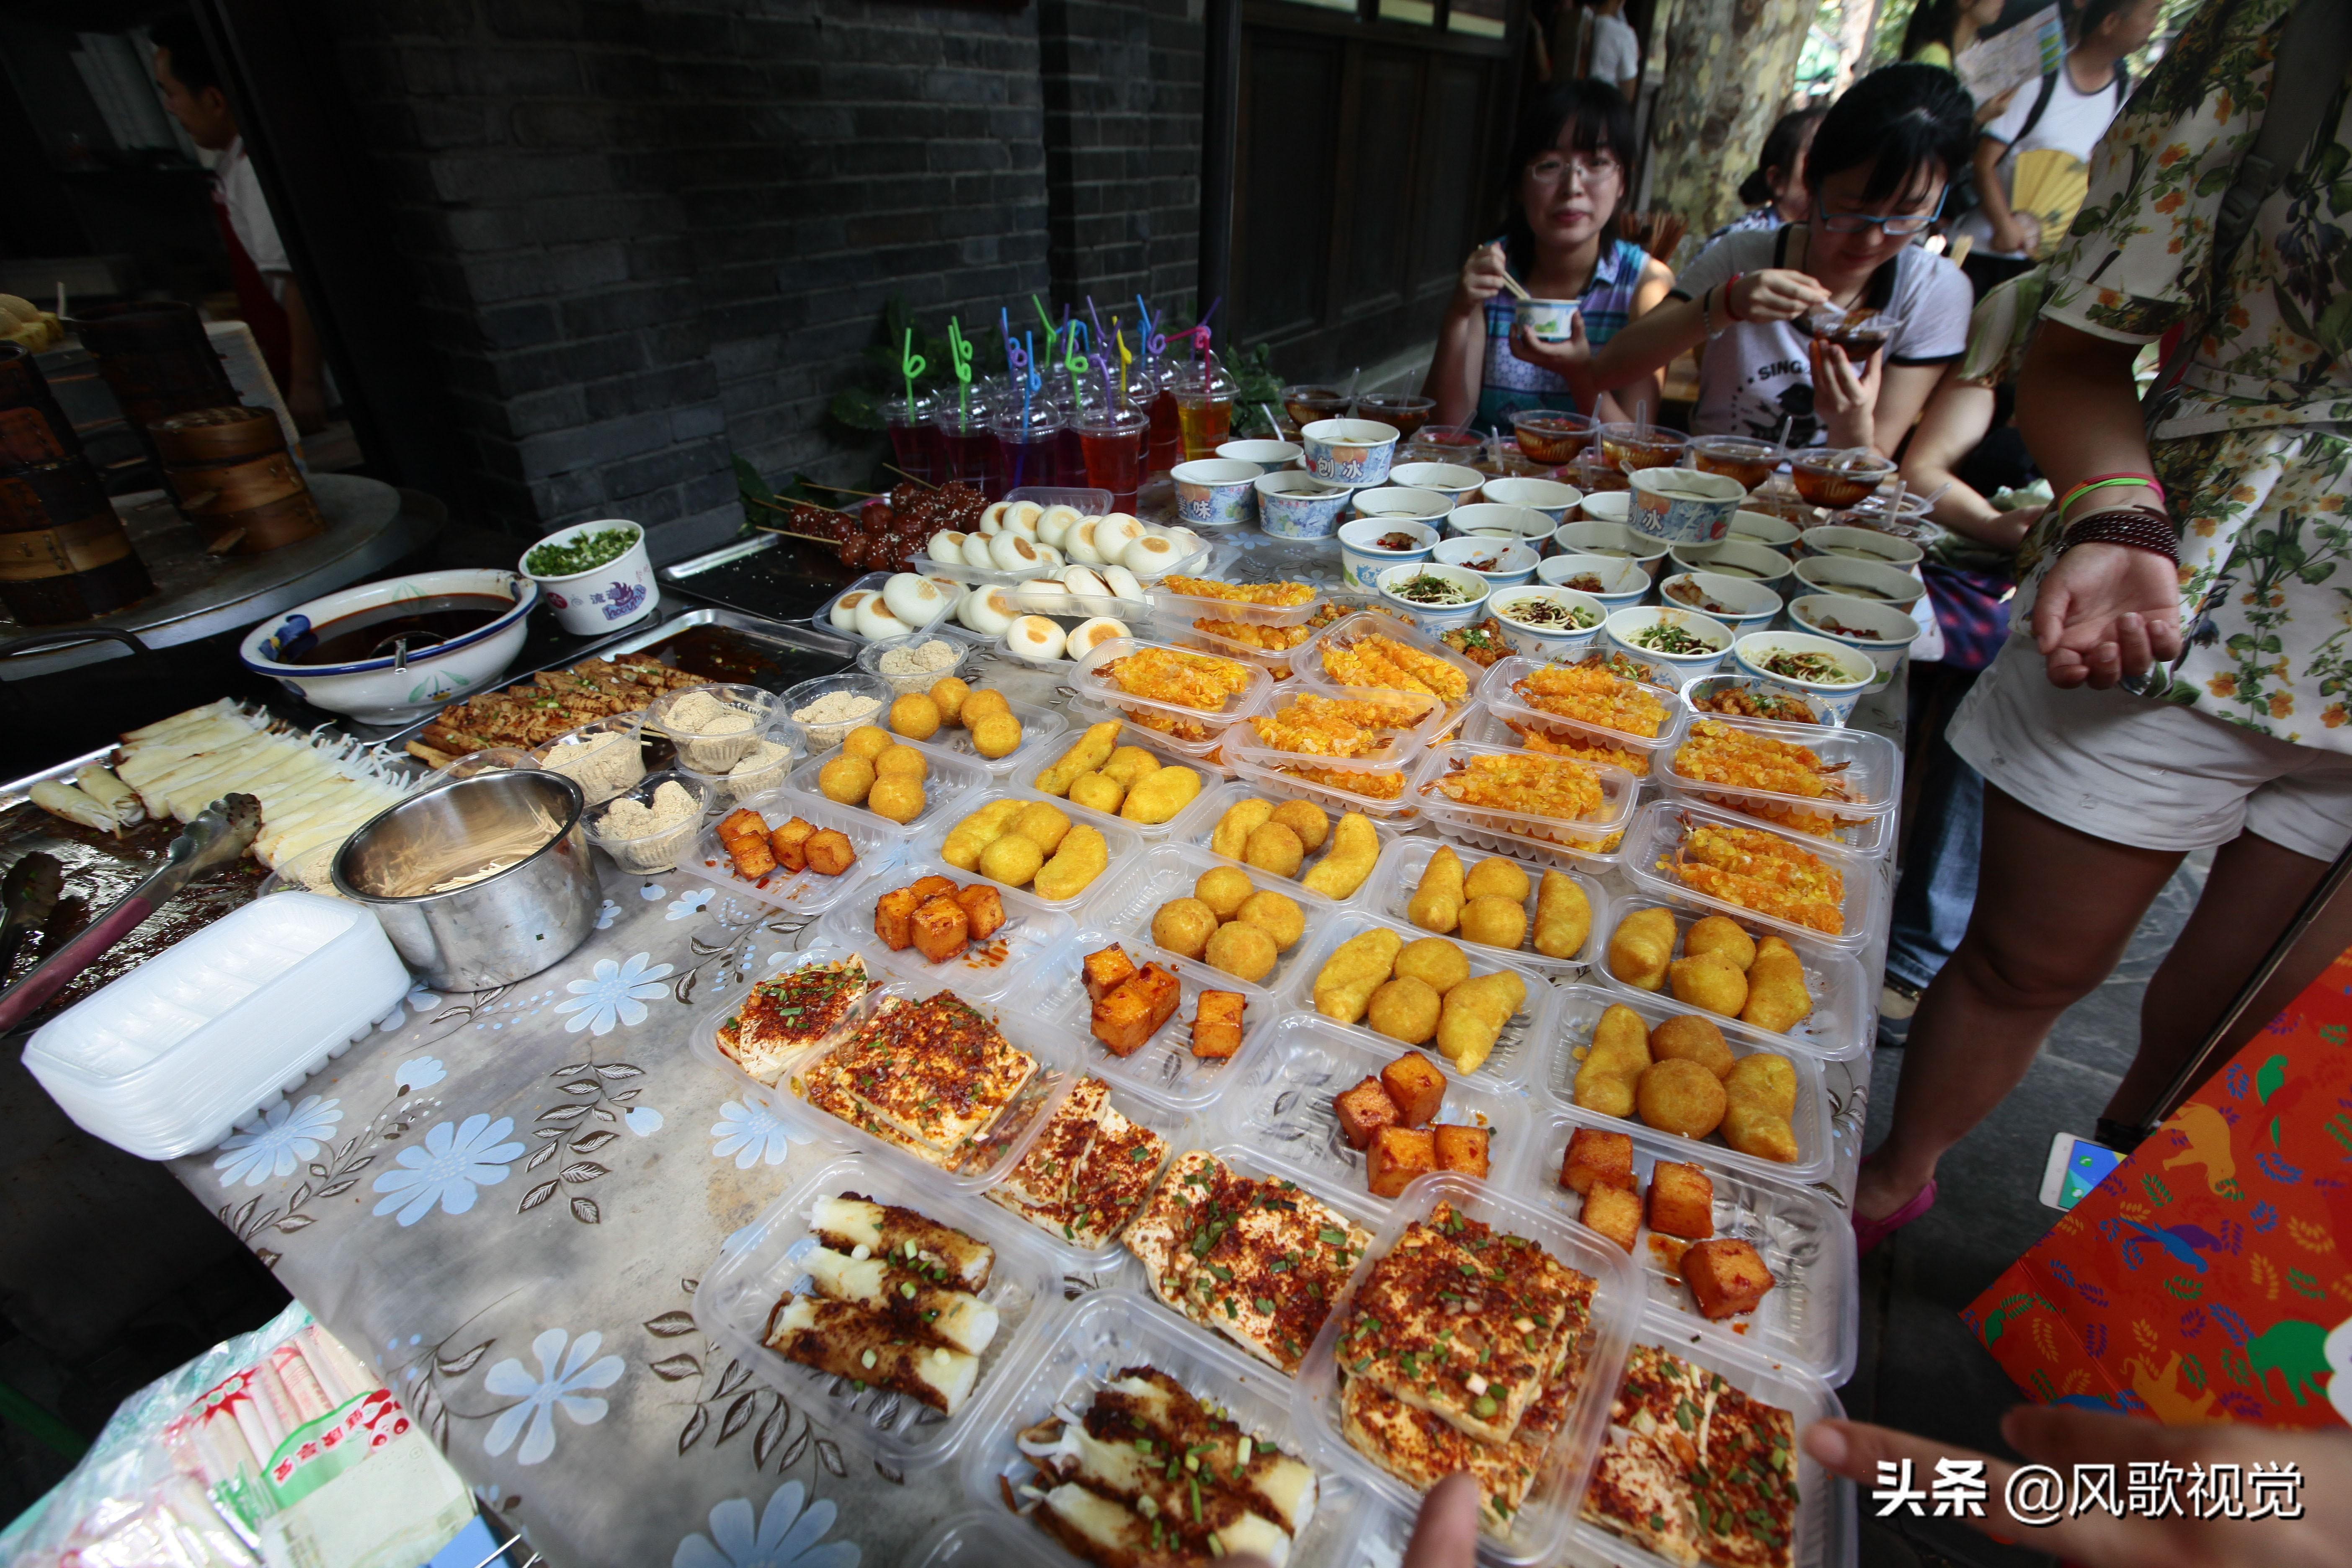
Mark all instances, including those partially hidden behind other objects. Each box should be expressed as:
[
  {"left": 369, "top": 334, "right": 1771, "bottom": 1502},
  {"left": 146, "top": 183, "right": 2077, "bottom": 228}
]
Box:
[{"left": 1019, "top": 1366, "right": 1317, "bottom": 1565}]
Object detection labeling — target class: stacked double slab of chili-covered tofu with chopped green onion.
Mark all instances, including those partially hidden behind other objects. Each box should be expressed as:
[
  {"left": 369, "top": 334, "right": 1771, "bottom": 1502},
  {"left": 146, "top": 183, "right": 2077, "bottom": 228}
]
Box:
[{"left": 1336, "top": 1204, "right": 1592, "bottom": 1444}]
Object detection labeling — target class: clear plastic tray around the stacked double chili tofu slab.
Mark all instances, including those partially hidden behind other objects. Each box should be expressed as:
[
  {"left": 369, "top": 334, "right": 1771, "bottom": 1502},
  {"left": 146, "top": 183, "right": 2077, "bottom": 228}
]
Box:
[{"left": 1291, "top": 1173, "right": 1642, "bottom": 1565}]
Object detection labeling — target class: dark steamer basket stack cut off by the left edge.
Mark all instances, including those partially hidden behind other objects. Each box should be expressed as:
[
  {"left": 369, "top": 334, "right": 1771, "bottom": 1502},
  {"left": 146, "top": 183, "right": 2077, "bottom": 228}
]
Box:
[{"left": 0, "top": 343, "right": 155, "bottom": 625}]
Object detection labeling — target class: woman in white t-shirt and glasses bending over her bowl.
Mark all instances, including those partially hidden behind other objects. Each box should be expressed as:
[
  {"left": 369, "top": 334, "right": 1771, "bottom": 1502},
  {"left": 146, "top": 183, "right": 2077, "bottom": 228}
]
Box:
[{"left": 1512, "top": 66, "right": 1975, "bottom": 451}]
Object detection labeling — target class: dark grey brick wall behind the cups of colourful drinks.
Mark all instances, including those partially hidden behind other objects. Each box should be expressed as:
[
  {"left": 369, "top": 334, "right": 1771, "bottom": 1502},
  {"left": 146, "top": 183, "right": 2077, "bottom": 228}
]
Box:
[{"left": 332, "top": 0, "right": 1202, "bottom": 557}]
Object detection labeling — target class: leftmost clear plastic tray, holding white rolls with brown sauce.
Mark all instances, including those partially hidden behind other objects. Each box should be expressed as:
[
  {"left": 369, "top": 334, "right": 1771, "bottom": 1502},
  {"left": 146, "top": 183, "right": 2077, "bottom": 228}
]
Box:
[{"left": 694, "top": 1154, "right": 1061, "bottom": 1469}]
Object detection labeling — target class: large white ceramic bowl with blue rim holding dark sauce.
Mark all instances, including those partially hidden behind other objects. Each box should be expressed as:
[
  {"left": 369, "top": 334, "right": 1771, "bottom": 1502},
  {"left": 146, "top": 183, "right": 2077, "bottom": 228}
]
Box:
[{"left": 237, "top": 567, "right": 539, "bottom": 724}]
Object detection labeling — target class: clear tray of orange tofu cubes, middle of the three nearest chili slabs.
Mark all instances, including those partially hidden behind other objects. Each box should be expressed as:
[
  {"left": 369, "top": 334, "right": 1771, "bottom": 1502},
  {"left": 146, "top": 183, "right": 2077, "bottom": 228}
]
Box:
[{"left": 1218, "top": 1011, "right": 1536, "bottom": 1208}]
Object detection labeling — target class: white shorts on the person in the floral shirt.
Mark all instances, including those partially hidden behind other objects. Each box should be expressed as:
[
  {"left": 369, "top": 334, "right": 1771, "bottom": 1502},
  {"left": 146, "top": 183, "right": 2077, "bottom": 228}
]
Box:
[{"left": 1947, "top": 637, "right": 2352, "bottom": 860}]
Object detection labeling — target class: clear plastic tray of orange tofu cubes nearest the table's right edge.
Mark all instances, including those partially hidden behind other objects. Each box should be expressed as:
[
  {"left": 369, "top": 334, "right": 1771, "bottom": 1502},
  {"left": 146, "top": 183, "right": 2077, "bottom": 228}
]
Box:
[{"left": 1510, "top": 1107, "right": 1863, "bottom": 1387}]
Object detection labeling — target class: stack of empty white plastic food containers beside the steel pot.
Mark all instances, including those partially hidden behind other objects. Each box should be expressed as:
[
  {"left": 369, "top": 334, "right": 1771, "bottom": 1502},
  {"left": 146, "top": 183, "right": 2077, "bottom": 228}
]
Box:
[{"left": 23, "top": 891, "right": 409, "bottom": 1159}]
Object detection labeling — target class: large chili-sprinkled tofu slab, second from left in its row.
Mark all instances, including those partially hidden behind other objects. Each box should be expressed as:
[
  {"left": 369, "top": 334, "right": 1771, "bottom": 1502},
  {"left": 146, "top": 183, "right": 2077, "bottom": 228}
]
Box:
[{"left": 795, "top": 992, "right": 1037, "bottom": 1171}]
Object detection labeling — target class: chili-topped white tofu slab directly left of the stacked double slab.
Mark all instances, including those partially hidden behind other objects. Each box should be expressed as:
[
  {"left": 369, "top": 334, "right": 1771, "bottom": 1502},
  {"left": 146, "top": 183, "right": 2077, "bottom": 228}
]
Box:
[{"left": 1127, "top": 1150, "right": 1371, "bottom": 1373}]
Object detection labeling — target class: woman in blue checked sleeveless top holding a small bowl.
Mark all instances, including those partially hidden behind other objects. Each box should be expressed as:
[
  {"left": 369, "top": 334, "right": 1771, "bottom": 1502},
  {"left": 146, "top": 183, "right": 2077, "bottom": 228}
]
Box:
[{"left": 1421, "top": 82, "right": 1675, "bottom": 433}]
